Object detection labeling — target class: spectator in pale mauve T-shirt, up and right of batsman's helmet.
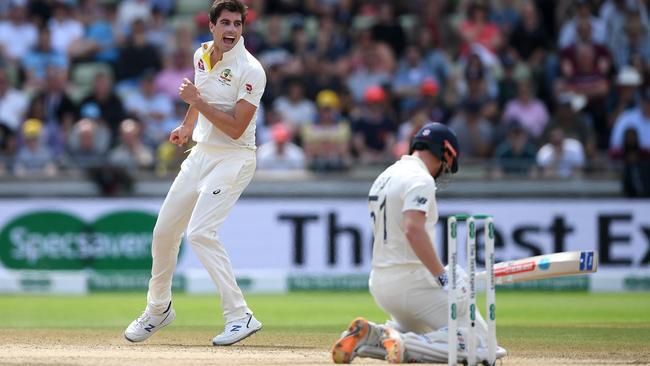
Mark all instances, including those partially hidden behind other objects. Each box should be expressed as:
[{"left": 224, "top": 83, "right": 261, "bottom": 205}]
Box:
[{"left": 503, "top": 79, "right": 549, "bottom": 139}]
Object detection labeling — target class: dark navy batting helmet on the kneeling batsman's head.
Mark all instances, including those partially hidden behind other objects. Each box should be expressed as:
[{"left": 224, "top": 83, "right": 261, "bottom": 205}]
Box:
[{"left": 410, "top": 122, "right": 460, "bottom": 173}]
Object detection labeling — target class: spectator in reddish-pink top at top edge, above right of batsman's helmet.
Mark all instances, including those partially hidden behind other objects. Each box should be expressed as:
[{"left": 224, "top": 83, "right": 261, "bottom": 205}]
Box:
[{"left": 459, "top": 1, "right": 503, "bottom": 56}]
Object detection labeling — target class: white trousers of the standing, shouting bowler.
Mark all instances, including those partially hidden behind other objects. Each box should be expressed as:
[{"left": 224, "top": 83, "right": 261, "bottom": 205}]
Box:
[{"left": 147, "top": 143, "right": 255, "bottom": 322}]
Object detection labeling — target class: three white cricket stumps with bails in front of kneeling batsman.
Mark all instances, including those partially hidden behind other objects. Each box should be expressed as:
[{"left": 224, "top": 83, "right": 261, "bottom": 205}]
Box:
[{"left": 447, "top": 214, "right": 497, "bottom": 366}]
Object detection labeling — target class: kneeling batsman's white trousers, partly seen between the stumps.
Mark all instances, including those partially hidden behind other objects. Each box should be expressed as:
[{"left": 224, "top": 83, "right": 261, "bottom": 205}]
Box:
[{"left": 369, "top": 264, "right": 487, "bottom": 340}]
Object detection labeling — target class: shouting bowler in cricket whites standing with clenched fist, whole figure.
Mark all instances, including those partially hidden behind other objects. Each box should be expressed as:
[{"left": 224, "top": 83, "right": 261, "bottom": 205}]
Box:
[{"left": 124, "top": 0, "right": 266, "bottom": 346}]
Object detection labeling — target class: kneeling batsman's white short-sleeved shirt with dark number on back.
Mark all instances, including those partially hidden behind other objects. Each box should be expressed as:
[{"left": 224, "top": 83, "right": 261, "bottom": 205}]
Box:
[{"left": 368, "top": 155, "right": 438, "bottom": 268}]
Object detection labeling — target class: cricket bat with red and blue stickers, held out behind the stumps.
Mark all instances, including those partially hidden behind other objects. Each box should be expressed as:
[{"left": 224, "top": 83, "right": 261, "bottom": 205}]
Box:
[{"left": 476, "top": 250, "right": 598, "bottom": 285}]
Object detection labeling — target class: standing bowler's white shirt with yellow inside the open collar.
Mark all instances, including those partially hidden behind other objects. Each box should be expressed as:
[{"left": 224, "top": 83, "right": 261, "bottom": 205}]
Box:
[{"left": 192, "top": 37, "right": 266, "bottom": 150}]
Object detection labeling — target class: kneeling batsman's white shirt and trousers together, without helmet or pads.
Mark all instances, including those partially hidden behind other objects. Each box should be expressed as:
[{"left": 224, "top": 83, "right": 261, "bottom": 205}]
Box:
[{"left": 369, "top": 155, "right": 487, "bottom": 339}]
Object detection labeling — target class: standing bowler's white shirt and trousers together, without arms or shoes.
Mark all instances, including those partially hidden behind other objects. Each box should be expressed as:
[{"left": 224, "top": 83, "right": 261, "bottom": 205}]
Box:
[{"left": 147, "top": 38, "right": 266, "bottom": 322}]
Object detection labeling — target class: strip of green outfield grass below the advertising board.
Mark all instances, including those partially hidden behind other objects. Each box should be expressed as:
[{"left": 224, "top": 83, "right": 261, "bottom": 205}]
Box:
[{"left": 0, "top": 292, "right": 650, "bottom": 362}]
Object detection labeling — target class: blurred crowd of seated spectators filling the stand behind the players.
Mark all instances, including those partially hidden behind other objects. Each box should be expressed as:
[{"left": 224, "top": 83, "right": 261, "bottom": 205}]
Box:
[{"left": 0, "top": 0, "right": 650, "bottom": 195}]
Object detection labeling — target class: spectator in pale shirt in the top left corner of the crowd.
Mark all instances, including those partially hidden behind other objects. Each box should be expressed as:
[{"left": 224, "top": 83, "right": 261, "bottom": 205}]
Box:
[{"left": 0, "top": 3, "right": 38, "bottom": 62}]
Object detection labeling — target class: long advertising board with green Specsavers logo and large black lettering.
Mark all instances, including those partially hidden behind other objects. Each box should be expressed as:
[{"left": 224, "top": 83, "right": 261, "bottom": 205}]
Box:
[{"left": 0, "top": 198, "right": 650, "bottom": 274}]
